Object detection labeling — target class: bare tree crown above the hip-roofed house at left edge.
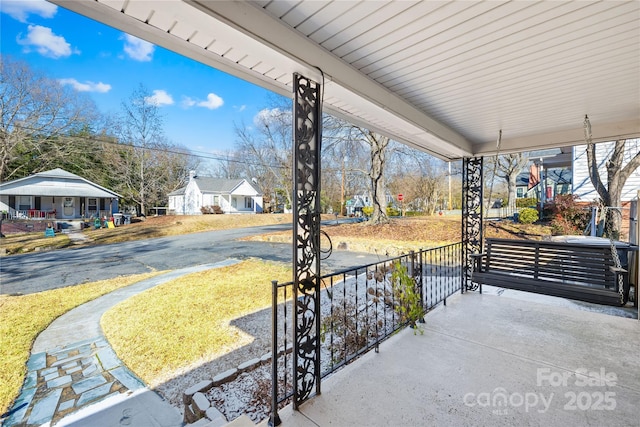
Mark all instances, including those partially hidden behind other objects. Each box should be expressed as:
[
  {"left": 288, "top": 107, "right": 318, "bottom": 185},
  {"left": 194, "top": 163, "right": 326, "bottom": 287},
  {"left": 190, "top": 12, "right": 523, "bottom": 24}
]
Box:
[{"left": 0, "top": 55, "right": 97, "bottom": 181}]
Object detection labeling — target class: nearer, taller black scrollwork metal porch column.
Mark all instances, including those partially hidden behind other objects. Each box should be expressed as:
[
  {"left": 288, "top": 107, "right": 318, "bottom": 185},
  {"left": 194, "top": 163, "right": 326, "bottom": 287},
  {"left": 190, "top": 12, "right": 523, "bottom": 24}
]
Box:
[{"left": 293, "top": 74, "right": 322, "bottom": 409}]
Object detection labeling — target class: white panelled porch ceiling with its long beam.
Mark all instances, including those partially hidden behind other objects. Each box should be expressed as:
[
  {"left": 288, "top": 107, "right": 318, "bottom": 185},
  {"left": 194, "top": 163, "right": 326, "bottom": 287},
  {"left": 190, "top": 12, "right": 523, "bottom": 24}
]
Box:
[{"left": 50, "top": 0, "right": 640, "bottom": 159}]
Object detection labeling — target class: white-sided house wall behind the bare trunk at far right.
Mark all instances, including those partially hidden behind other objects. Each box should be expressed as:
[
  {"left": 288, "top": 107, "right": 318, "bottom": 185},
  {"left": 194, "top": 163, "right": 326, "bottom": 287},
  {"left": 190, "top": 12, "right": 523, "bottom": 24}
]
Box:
[{"left": 572, "top": 139, "right": 640, "bottom": 202}]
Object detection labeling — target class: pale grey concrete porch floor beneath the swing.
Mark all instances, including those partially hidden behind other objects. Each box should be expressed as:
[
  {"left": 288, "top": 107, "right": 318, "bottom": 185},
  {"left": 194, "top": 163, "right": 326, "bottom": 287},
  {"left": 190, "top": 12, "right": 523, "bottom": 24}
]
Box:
[{"left": 280, "top": 292, "right": 640, "bottom": 427}]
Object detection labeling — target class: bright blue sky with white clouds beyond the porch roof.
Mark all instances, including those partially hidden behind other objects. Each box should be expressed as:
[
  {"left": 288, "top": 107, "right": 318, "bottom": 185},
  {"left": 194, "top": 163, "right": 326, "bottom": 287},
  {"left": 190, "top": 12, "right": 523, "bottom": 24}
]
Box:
[{"left": 0, "top": 0, "right": 271, "bottom": 154}]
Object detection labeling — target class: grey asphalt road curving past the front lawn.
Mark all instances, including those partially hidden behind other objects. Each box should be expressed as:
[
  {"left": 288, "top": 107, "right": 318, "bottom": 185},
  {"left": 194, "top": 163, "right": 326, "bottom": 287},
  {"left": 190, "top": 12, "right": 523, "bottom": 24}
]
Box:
[{"left": 0, "top": 224, "right": 378, "bottom": 294}]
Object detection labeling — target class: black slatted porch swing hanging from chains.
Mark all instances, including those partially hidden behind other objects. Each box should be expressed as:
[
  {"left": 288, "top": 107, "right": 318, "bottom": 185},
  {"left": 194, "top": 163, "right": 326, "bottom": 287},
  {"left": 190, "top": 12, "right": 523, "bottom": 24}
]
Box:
[{"left": 471, "top": 238, "right": 629, "bottom": 306}]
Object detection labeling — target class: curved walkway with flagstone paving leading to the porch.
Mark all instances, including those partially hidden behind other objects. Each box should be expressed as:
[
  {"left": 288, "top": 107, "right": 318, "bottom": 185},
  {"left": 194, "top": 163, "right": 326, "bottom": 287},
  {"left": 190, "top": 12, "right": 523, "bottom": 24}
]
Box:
[{"left": 2, "top": 260, "right": 238, "bottom": 427}]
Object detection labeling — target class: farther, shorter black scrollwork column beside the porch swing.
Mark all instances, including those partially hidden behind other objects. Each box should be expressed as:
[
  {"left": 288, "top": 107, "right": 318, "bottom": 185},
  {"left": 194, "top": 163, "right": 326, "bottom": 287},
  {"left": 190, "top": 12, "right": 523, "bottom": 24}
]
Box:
[{"left": 462, "top": 157, "right": 483, "bottom": 292}]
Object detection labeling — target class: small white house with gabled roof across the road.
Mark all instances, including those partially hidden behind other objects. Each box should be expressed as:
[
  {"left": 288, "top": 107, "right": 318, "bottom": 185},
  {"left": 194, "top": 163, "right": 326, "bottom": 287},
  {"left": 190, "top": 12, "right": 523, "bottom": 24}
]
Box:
[{"left": 169, "top": 172, "right": 263, "bottom": 215}]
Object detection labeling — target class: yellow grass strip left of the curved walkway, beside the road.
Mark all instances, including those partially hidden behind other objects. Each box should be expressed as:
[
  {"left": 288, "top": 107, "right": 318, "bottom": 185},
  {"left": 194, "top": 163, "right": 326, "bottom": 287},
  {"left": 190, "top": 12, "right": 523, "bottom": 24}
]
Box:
[{"left": 0, "top": 272, "right": 160, "bottom": 413}]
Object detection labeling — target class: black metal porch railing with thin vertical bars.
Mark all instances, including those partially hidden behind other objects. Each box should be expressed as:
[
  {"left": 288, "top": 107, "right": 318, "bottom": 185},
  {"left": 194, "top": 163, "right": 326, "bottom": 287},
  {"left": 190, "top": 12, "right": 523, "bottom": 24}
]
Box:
[{"left": 269, "top": 243, "right": 464, "bottom": 425}]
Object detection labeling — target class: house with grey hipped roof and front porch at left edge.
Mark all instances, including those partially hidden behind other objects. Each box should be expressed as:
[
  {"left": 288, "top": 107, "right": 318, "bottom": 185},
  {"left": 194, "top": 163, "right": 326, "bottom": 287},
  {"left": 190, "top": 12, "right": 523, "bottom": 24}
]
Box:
[{"left": 0, "top": 168, "right": 122, "bottom": 219}]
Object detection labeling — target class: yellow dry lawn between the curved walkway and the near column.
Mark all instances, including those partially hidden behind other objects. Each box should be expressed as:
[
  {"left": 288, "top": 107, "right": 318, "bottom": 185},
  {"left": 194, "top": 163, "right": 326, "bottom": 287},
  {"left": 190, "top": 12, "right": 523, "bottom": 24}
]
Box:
[{"left": 101, "top": 260, "right": 291, "bottom": 387}]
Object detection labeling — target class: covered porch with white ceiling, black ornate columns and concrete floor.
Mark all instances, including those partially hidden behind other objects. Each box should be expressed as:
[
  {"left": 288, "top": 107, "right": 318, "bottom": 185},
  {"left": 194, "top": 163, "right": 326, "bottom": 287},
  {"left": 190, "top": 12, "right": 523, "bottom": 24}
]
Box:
[{"left": 42, "top": 0, "right": 640, "bottom": 425}]
